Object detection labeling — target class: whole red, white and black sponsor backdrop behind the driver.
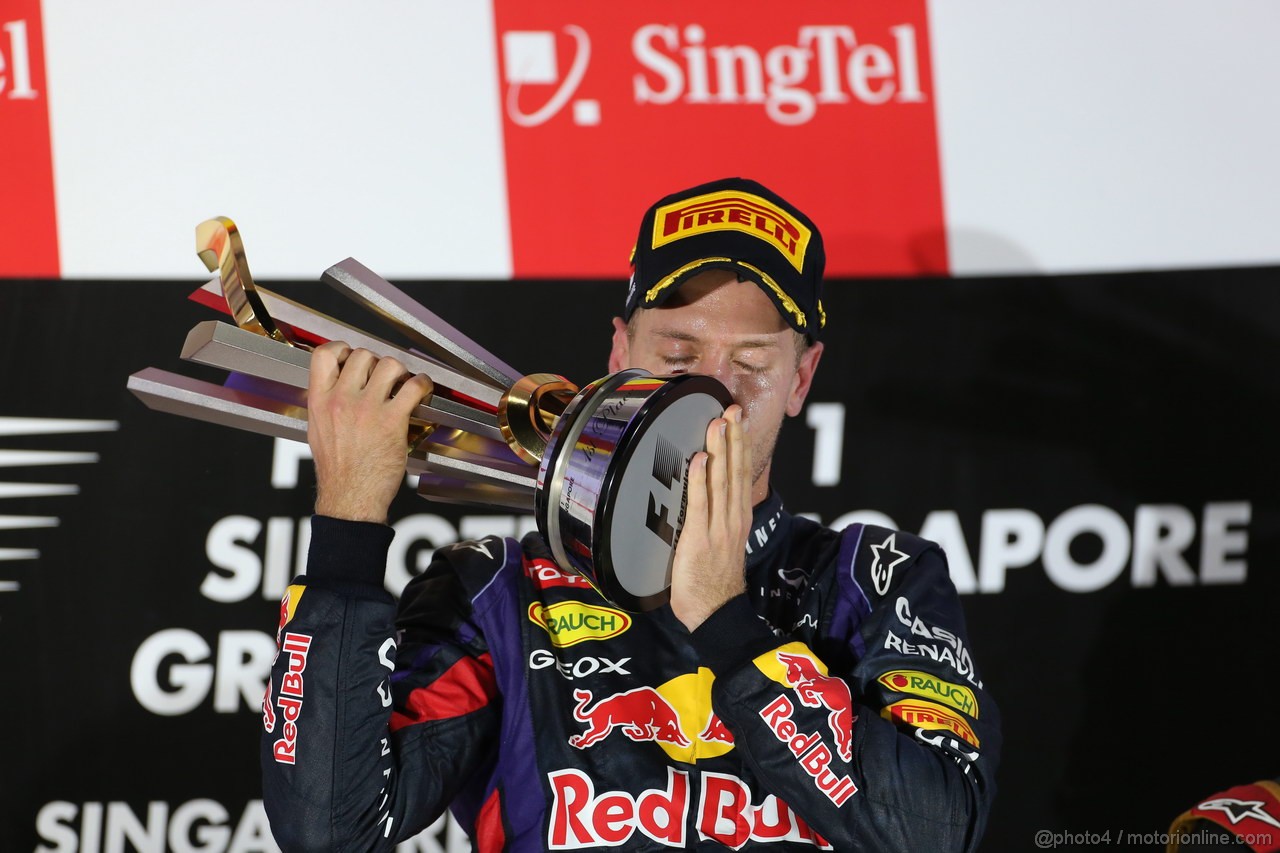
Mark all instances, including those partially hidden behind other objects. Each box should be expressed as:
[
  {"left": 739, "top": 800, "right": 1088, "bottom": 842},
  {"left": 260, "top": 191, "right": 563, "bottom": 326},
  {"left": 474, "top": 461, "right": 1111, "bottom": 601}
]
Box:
[{"left": 0, "top": 0, "right": 1280, "bottom": 853}]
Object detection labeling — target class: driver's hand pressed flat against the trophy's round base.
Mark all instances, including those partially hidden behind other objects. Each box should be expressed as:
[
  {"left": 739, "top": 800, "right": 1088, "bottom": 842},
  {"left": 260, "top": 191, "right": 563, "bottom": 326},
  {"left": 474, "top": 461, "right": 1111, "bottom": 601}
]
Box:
[{"left": 671, "top": 405, "right": 751, "bottom": 631}]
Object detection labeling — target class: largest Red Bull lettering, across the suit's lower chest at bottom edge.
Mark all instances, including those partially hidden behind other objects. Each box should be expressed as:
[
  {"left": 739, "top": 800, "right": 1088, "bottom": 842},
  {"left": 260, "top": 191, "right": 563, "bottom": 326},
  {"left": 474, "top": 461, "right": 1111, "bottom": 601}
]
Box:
[{"left": 547, "top": 767, "right": 832, "bottom": 850}]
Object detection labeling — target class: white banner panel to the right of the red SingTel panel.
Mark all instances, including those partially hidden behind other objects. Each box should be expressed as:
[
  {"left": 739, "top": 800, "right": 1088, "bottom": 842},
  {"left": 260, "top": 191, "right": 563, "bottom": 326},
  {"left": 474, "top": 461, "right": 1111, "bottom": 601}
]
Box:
[{"left": 929, "top": 0, "right": 1280, "bottom": 274}]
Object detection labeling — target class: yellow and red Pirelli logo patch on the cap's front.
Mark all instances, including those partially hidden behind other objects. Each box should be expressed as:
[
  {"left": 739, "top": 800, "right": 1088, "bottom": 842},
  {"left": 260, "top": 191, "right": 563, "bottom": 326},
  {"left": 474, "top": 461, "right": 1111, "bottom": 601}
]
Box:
[{"left": 653, "top": 190, "right": 812, "bottom": 273}]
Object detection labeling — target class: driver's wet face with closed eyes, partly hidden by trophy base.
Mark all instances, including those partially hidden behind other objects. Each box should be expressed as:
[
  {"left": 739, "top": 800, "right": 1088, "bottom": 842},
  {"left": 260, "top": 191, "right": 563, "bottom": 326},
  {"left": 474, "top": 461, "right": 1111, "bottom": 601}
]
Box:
[{"left": 609, "top": 270, "right": 822, "bottom": 502}]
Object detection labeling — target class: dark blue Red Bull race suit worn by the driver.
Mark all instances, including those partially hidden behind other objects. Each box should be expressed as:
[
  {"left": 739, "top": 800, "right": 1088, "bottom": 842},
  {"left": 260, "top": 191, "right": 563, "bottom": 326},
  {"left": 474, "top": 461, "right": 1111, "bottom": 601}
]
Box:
[{"left": 262, "top": 494, "right": 1000, "bottom": 852}]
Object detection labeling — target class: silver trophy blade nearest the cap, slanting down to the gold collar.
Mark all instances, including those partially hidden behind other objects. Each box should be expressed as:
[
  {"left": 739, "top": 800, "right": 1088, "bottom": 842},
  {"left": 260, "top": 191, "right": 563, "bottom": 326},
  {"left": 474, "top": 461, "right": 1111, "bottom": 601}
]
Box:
[{"left": 320, "top": 257, "right": 522, "bottom": 389}]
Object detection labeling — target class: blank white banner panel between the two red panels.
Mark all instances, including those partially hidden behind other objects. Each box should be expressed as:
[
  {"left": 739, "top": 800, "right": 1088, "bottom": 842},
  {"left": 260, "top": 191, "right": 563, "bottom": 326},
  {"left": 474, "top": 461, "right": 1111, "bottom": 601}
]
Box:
[{"left": 44, "top": 0, "right": 511, "bottom": 278}]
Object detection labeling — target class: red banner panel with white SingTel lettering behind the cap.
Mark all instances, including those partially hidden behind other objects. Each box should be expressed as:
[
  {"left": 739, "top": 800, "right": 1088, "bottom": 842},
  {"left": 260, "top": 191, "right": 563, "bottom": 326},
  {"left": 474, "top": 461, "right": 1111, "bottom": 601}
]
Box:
[{"left": 495, "top": 0, "right": 947, "bottom": 278}]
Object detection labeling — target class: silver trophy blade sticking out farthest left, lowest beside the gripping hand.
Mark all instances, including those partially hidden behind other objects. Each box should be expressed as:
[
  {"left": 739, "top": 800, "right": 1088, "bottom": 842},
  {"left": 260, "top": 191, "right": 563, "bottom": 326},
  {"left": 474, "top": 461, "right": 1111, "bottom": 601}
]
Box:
[{"left": 128, "top": 368, "right": 307, "bottom": 442}]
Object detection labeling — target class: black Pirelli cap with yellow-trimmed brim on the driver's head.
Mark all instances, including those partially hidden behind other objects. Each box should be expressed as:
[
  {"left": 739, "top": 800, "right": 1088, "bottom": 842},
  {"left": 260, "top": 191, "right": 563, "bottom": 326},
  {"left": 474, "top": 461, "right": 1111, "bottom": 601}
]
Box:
[{"left": 622, "top": 178, "right": 827, "bottom": 341}]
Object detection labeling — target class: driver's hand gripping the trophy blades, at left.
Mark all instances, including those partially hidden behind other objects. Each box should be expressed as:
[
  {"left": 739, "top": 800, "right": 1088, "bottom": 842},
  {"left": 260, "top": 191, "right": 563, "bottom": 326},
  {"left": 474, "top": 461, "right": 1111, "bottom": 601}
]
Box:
[{"left": 307, "top": 341, "right": 433, "bottom": 524}]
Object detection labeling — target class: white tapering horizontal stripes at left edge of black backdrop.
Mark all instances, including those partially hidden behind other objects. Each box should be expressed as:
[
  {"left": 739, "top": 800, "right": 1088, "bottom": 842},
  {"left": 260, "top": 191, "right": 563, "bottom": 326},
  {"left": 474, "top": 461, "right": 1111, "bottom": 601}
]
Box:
[{"left": 0, "top": 418, "right": 119, "bottom": 592}]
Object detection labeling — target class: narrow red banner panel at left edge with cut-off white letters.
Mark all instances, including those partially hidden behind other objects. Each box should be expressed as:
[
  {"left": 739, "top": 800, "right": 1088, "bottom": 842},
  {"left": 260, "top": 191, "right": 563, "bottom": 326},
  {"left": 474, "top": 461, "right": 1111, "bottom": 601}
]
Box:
[{"left": 0, "top": 0, "right": 58, "bottom": 278}]
